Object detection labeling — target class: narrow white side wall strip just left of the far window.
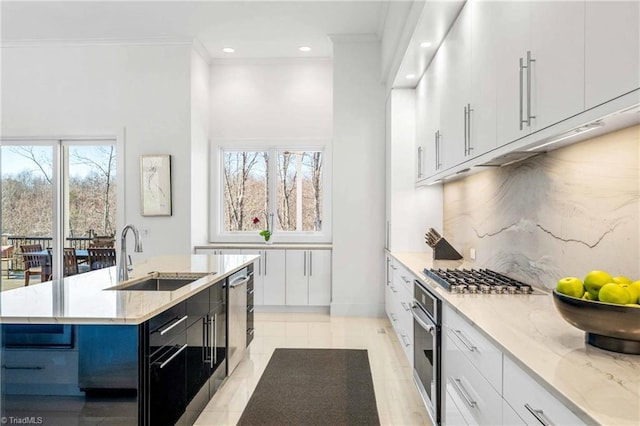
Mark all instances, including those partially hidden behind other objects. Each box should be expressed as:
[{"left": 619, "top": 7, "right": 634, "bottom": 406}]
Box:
[{"left": 191, "top": 50, "right": 211, "bottom": 250}]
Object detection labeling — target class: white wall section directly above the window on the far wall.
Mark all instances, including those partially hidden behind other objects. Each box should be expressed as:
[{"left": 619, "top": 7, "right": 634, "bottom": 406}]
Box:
[{"left": 211, "top": 59, "right": 333, "bottom": 140}]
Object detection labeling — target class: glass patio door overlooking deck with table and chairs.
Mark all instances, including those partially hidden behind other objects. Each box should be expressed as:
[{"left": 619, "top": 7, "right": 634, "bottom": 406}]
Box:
[{"left": 0, "top": 139, "right": 116, "bottom": 291}]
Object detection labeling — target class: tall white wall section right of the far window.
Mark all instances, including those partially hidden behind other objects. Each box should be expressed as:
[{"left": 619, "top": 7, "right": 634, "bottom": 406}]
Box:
[{"left": 331, "top": 37, "right": 385, "bottom": 316}]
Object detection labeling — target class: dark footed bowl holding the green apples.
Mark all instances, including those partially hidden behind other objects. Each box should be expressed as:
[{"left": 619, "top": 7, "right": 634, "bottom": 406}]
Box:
[{"left": 553, "top": 290, "right": 640, "bottom": 354}]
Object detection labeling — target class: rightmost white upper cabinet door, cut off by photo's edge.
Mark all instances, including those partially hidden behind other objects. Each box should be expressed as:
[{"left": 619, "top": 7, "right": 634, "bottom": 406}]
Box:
[{"left": 585, "top": 1, "right": 640, "bottom": 109}]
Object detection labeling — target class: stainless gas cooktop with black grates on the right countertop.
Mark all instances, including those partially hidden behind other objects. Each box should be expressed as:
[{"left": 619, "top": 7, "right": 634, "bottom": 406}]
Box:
[{"left": 424, "top": 268, "right": 534, "bottom": 294}]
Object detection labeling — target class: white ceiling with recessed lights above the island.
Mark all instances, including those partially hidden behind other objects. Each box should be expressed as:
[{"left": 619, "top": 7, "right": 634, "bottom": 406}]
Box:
[{"left": 0, "top": 0, "right": 387, "bottom": 58}]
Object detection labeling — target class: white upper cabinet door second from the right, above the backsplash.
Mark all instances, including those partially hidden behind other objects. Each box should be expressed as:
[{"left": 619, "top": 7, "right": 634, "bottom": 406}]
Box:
[{"left": 523, "top": 1, "right": 585, "bottom": 130}]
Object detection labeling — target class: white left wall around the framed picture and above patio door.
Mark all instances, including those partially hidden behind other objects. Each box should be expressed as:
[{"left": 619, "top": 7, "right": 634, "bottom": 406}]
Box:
[{"left": 1, "top": 44, "right": 191, "bottom": 261}]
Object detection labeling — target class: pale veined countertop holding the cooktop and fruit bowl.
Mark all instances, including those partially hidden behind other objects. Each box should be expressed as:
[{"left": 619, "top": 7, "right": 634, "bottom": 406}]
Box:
[{"left": 391, "top": 253, "right": 640, "bottom": 425}]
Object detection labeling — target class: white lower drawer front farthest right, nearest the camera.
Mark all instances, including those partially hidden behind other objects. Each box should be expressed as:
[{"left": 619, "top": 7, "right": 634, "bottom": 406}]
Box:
[{"left": 504, "top": 357, "right": 584, "bottom": 425}]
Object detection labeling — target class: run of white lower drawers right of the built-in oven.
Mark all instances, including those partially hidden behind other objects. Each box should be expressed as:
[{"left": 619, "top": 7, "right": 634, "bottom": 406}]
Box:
[{"left": 441, "top": 304, "right": 584, "bottom": 425}]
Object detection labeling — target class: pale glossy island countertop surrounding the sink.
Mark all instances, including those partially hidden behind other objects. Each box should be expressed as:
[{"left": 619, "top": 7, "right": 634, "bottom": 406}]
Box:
[{"left": 0, "top": 255, "right": 258, "bottom": 324}]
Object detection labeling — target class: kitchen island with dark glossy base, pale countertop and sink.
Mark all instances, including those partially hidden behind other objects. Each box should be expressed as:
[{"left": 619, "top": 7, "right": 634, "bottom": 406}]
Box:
[{"left": 0, "top": 255, "right": 257, "bottom": 425}]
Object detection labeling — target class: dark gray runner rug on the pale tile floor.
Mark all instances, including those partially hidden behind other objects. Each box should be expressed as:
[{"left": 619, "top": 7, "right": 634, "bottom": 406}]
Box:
[{"left": 238, "top": 348, "right": 380, "bottom": 425}]
